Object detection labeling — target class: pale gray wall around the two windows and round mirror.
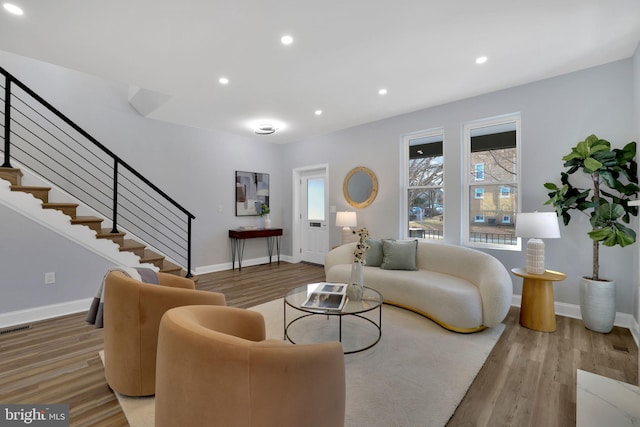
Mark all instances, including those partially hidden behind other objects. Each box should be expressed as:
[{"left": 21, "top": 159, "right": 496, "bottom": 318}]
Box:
[{"left": 282, "top": 60, "right": 638, "bottom": 314}]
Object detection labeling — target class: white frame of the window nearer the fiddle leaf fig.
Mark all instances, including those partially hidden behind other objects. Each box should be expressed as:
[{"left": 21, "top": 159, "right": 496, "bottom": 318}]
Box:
[{"left": 461, "top": 113, "right": 522, "bottom": 251}]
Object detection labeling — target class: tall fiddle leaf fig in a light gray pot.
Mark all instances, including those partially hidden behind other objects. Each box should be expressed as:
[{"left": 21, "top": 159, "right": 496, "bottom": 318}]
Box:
[{"left": 544, "top": 135, "right": 640, "bottom": 333}]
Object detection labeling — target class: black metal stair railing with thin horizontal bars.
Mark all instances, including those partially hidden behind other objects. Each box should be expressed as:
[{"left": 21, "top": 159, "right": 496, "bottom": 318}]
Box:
[{"left": 0, "top": 67, "right": 195, "bottom": 277}]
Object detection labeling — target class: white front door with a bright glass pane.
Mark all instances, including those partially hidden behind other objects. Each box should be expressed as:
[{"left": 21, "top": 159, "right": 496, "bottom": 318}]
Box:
[{"left": 298, "top": 169, "right": 329, "bottom": 264}]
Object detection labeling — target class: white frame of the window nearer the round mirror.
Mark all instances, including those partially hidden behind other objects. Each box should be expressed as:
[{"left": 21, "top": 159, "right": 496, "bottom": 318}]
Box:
[{"left": 398, "top": 127, "right": 447, "bottom": 242}]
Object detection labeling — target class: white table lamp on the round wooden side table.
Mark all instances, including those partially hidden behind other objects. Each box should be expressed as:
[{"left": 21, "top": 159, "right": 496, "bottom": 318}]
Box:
[{"left": 516, "top": 212, "right": 560, "bottom": 274}]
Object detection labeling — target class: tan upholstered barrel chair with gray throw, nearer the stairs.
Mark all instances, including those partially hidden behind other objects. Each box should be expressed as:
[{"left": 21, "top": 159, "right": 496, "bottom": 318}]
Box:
[{"left": 104, "top": 271, "right": 225, "bottom": 396}]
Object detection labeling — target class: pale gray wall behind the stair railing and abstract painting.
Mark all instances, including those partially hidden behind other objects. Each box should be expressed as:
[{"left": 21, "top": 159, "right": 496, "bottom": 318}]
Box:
[{"left": 0, "top": 51, "right": 290, "bottom": 267}]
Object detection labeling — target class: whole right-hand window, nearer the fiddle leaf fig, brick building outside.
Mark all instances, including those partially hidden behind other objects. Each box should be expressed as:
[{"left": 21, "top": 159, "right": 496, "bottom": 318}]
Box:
[{"left": 463, "top": 114, "right": 520, "bottom": 250}]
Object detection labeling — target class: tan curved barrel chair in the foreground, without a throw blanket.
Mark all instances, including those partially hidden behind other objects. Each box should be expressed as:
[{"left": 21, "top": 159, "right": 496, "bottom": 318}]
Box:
[{"left": 155, "top": 306, "right": 345, "bottom": 427}]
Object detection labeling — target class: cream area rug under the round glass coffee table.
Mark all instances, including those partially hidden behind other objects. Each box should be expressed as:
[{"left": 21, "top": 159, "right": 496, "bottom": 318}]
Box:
[{"left": 106, "top": 299, "right": 504, "bottom": 427}]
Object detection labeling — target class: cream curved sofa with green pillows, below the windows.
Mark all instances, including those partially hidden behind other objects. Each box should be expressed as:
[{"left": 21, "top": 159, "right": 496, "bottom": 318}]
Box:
[{"left": 324, "top": 241, "right": 513, "bottom": 333}]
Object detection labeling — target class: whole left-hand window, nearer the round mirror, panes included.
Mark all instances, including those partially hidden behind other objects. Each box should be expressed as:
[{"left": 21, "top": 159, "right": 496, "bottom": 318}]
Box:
[{"left": 403, "top": 130, "right": 445, "bottom": 239}]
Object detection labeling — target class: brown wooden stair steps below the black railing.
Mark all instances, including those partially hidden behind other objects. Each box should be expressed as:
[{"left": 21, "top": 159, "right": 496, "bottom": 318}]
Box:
[{"left": 0, "top": 167, "right": 185, "bottom": 279}]
